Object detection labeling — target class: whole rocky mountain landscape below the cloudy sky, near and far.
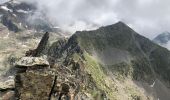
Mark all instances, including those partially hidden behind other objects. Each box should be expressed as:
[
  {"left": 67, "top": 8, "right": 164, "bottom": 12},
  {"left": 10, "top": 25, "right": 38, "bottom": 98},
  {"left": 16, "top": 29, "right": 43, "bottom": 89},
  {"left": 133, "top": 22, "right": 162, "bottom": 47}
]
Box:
[{"left": 0, "top": 0, "right": 170, "bottom": 100}]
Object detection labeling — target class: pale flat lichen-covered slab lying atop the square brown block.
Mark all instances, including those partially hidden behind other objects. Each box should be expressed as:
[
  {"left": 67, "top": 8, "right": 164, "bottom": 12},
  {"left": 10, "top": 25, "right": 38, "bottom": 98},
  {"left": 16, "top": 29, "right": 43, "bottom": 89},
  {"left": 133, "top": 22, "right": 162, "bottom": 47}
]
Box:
[{"left": 15, "top": 57, "right": 49, "bottom": 68}]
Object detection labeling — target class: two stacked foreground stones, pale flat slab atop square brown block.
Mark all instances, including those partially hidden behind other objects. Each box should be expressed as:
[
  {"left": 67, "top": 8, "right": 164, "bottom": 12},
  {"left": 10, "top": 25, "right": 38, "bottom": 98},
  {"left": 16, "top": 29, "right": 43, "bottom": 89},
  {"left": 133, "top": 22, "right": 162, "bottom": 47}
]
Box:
[{"left": 15, "top": 57, "right": 56, "bottom": 100}]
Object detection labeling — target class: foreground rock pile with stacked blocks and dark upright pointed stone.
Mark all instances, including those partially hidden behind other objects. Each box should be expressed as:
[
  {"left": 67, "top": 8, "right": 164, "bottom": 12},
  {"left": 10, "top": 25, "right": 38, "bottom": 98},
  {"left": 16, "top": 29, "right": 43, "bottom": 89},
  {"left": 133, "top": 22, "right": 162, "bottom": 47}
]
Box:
[{"left": 0, "top": 33, "right": 82, "bottom": 100}]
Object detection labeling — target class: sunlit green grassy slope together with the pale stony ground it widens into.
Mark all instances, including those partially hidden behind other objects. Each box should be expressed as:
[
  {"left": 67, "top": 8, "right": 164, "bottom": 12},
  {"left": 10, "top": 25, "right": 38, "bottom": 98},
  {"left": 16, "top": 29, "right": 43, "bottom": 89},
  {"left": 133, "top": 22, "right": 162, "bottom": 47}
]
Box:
[{"left": 84, "top": 53, "right": 151, "bottom": 100}]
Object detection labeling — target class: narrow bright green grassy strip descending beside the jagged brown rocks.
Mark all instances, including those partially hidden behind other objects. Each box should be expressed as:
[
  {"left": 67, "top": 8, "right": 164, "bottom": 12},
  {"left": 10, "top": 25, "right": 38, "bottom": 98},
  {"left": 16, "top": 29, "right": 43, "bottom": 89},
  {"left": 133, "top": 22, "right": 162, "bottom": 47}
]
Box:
[{"left": 84, "top": 53, "right": 117, "bottom": 99}]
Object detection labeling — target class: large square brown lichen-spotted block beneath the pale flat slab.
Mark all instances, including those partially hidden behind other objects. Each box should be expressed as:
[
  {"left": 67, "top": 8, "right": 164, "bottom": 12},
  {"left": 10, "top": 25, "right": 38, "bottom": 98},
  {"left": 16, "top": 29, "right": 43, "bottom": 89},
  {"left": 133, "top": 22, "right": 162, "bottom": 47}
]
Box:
[{"left": 15, "top": 70, "right": 56, "bottom": 100}]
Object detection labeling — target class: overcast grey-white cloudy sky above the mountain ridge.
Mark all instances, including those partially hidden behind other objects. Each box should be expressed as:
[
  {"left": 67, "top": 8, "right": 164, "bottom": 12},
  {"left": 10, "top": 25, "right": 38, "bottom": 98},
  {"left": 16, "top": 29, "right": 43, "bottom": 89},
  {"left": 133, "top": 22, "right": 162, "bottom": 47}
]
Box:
[{"left": 0, "top": 0, "right": 170, "bottom": 38}]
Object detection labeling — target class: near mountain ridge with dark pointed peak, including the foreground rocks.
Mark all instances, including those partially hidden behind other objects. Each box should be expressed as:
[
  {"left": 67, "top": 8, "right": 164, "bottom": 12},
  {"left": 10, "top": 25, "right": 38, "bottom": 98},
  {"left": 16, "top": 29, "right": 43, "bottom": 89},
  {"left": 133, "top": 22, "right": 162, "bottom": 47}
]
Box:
[{"left": 0, "top": 22, "right": 170, "bottom": 100}]
